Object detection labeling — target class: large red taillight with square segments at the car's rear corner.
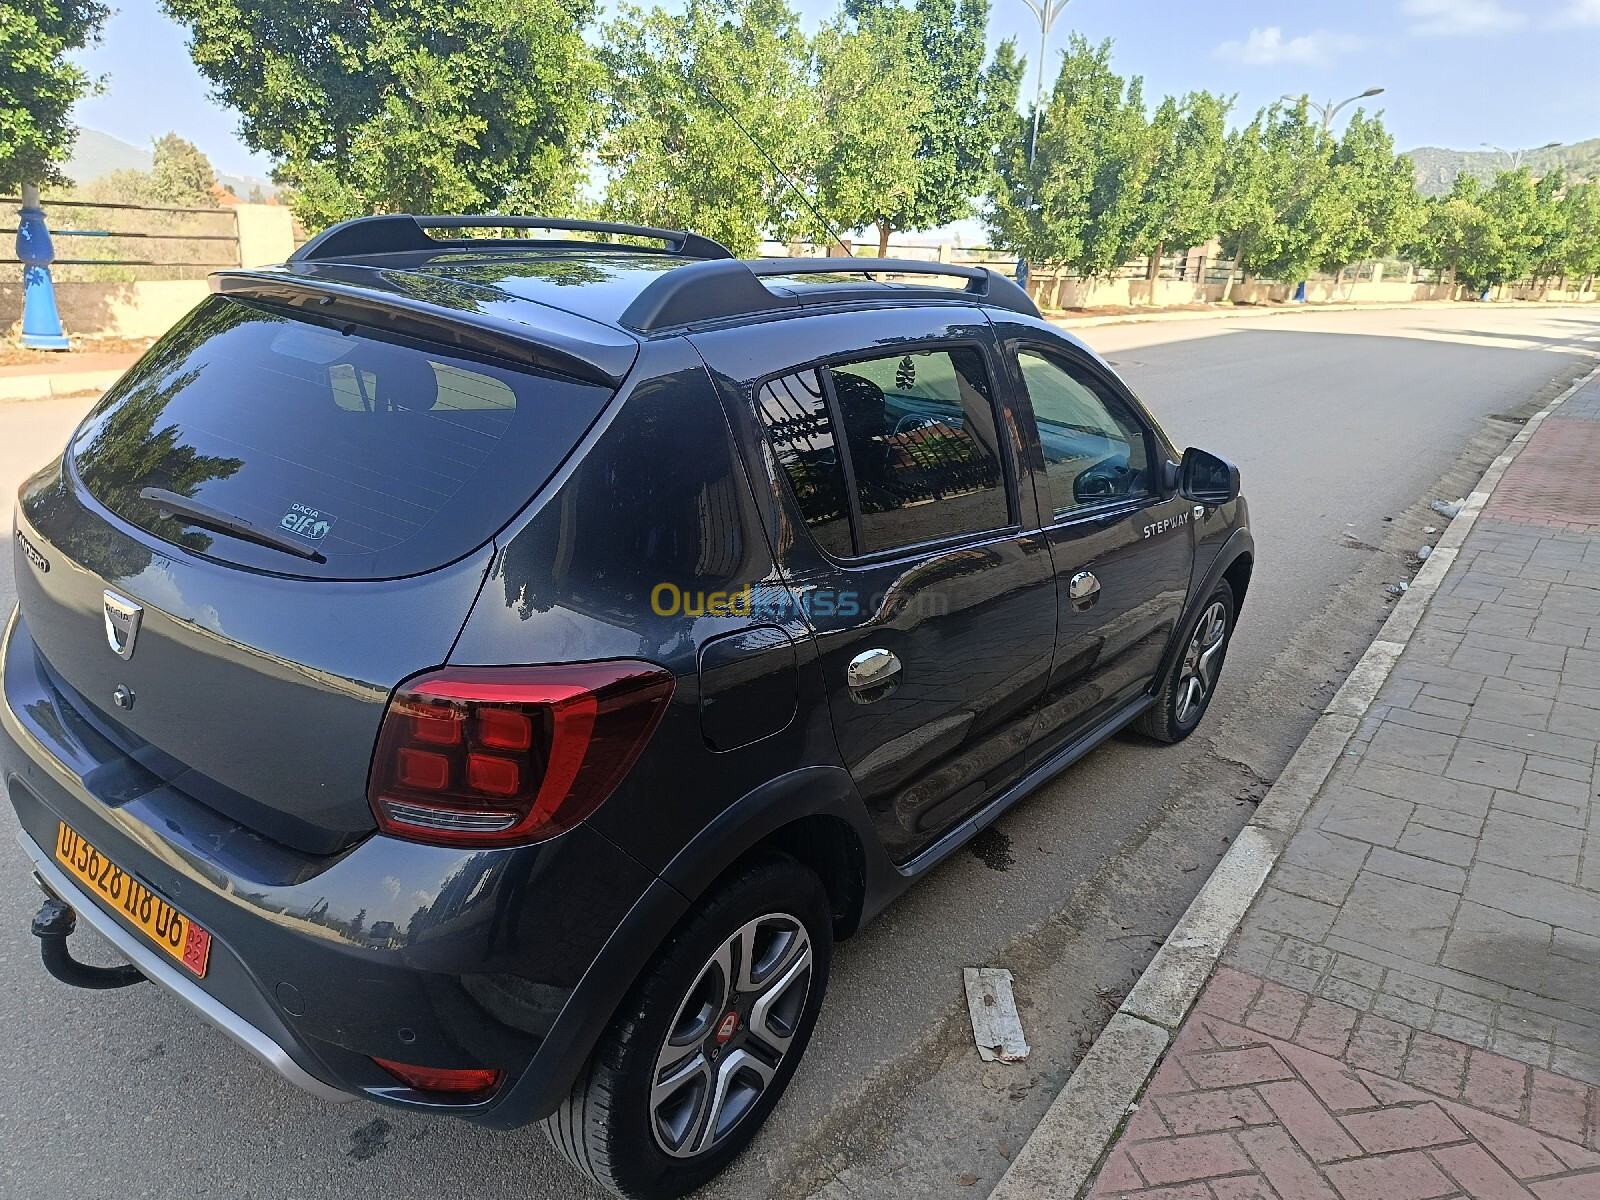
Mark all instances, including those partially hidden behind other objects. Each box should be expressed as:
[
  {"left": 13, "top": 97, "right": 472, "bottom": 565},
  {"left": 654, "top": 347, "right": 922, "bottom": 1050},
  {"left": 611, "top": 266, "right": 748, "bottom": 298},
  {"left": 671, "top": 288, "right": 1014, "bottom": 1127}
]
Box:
[{"left": 366, "top": 661, "right": 672, "bottom": 846}]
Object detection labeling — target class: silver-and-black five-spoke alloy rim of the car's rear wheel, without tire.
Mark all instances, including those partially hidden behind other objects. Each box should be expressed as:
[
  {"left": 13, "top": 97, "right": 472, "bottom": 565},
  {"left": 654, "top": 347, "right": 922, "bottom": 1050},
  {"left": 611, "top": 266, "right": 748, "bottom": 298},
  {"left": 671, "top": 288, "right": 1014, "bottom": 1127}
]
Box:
[{"left": 650, "top": 912, "right": 811, "bottom": 1158}]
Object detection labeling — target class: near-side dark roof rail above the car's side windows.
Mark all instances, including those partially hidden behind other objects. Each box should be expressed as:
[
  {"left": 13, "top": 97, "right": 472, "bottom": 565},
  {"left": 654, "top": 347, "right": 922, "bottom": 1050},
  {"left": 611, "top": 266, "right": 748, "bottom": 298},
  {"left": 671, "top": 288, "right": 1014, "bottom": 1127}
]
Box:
[{"left": 621, "top": 258, "right": 1038, "bottom": 333}]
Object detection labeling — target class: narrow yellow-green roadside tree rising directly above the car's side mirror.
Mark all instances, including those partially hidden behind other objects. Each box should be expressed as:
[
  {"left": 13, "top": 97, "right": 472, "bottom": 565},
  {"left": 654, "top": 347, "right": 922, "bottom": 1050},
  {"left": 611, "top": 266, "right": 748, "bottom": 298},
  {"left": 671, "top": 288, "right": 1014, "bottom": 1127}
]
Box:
[{"left": 1134, "top": 91, "right": 1234, "bottom": 280}]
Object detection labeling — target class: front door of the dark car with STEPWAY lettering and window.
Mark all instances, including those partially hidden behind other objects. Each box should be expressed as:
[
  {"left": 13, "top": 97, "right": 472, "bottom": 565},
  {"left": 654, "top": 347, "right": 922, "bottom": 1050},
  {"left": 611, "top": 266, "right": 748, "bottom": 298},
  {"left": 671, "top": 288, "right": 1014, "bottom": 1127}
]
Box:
[{"left": 1002, "top": 325, "right": 1194, "bottom": 762}]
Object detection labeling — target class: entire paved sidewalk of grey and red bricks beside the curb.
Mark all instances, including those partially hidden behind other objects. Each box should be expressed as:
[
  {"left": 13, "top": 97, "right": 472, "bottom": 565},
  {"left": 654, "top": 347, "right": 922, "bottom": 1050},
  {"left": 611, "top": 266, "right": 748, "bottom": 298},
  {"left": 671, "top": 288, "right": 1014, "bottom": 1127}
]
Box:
[{"left": 1090, "top": 379, "right": 1600, "bottom": 1200}]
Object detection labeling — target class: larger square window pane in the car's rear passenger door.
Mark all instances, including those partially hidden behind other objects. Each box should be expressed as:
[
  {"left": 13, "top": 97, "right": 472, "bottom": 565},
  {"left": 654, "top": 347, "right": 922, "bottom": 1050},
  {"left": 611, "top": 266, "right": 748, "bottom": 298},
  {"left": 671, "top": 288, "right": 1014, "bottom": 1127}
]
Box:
[{"left": 829, "top": 347, "right": 1010, "bottom": 554}]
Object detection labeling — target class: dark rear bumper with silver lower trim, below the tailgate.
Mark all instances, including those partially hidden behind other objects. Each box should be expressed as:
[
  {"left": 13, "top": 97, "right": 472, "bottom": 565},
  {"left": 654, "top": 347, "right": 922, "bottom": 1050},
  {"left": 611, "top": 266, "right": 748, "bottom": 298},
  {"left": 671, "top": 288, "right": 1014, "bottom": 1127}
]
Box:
[{"left": 0, "top": 618, "right": 685, "bottom": 1128}]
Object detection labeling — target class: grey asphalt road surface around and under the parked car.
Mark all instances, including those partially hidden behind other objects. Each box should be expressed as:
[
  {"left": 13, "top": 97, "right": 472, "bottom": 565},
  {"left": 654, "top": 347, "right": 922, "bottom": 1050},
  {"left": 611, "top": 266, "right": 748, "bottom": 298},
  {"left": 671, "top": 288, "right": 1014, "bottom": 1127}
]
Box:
[{"left": 0, "top": 306, "right": 1600, "bottom": 1200}]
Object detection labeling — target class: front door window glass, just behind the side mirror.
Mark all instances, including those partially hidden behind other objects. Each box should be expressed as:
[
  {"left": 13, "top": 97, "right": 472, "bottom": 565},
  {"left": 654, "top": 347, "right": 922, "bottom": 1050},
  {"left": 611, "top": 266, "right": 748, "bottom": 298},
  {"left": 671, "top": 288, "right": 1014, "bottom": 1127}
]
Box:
[{"left": 1018, "top": 350, "right": 1154, "bottom": 520}]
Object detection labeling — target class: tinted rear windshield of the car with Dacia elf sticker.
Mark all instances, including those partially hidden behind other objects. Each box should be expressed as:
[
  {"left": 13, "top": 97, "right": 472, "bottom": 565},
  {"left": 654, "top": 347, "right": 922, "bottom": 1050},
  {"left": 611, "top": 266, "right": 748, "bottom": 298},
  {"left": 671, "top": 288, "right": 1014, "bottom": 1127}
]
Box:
[{"left": 72, "top": 296, "right": 611, "bottom": 579}]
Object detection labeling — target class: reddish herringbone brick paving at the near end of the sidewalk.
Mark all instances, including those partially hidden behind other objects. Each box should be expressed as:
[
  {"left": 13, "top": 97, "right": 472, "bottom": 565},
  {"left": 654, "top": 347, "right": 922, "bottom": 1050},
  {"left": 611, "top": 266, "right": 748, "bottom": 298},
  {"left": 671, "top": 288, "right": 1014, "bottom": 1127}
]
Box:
[{"left": 1088, "top": 970, "right": 1600, "bottom": 1200}]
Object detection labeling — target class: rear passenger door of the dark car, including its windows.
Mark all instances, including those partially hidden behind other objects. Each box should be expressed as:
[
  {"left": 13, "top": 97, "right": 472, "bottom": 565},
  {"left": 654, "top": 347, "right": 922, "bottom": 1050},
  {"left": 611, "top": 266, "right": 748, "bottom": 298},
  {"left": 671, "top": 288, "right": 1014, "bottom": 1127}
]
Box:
[{"left": 696, "top": 307, "right": 1056, "bottom": 862}]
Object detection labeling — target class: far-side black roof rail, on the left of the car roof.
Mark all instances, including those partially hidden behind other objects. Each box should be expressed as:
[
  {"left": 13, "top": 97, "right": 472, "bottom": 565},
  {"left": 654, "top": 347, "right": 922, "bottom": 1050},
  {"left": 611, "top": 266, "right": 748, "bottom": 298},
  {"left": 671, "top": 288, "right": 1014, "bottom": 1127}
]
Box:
[{"left": 290, "top": 213, "right": 733, "bottom": 262}]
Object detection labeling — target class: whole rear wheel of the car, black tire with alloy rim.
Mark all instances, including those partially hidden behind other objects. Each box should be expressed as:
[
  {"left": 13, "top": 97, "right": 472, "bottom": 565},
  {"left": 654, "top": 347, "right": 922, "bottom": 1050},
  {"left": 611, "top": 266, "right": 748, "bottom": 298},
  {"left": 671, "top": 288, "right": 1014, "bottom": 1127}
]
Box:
[{"left": 544, "top": 854, "right": 834, "bottom": 1200}]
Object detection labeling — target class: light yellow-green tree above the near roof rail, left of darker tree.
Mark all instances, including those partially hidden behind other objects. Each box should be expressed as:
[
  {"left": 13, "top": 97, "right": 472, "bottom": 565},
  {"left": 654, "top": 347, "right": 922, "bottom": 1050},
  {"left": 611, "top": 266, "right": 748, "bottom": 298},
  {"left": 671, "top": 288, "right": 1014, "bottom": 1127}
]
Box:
[{"left": 805, "top": 6, "right": 933, "bottom": 258}]
